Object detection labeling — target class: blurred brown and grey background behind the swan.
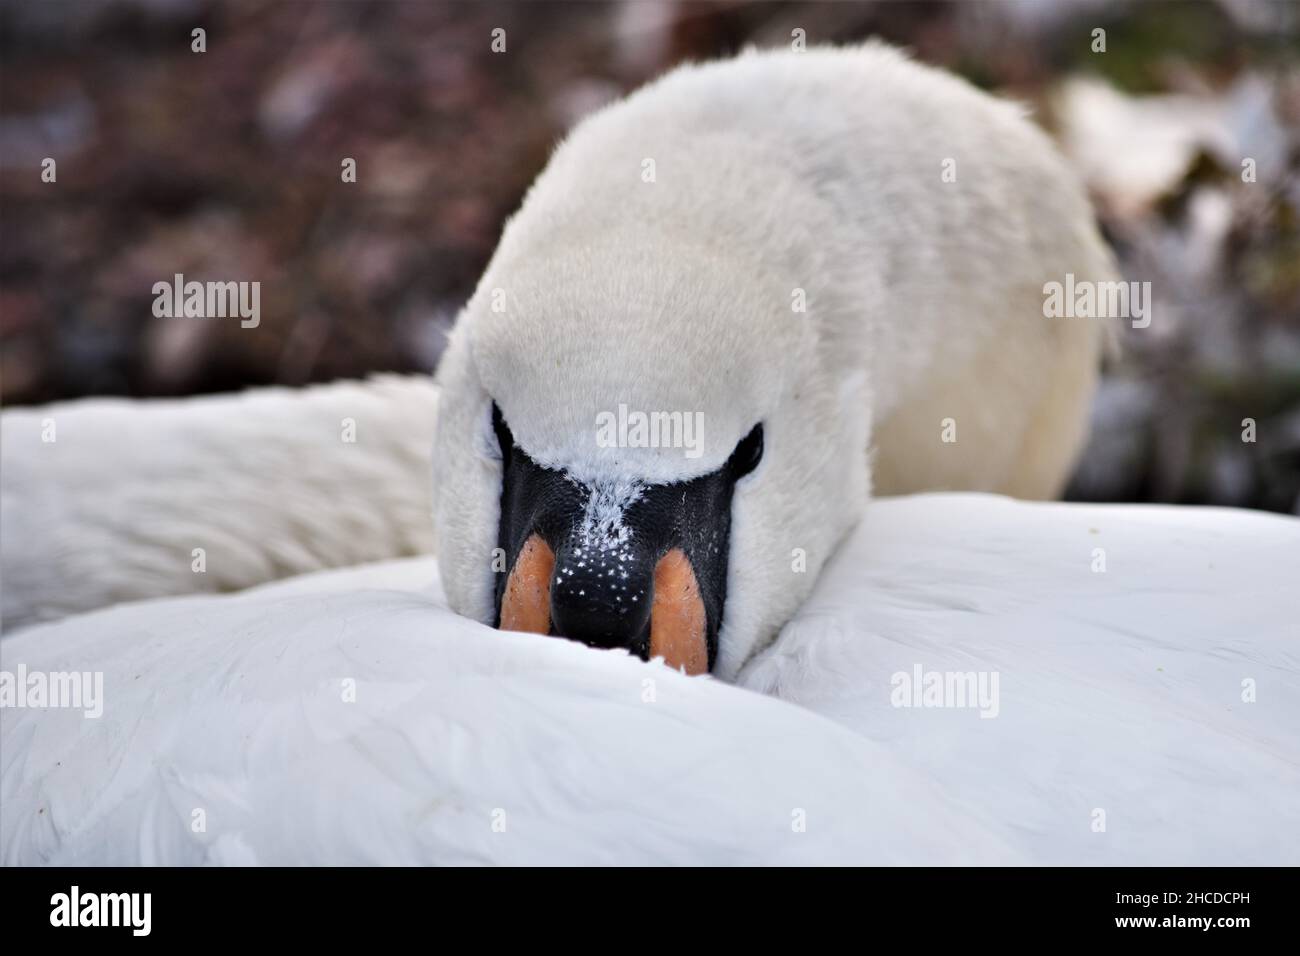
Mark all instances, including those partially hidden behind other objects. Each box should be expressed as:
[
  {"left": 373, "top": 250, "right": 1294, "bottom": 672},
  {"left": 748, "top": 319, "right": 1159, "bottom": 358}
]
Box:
[{"left": 0, "top": 0, "right": 1300, "bottom": 514}]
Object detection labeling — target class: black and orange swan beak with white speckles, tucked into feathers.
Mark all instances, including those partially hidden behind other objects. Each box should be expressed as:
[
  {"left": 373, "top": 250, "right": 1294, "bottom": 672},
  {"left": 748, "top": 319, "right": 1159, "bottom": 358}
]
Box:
[{"left": 493, "top": 405, "right": 743, "bottom": 674}]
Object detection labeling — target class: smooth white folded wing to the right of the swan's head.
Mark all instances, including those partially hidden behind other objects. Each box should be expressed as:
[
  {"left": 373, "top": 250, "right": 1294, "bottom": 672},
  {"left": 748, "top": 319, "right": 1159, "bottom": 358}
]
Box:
[{"left": 740, "top": 494, "right": 1300, "bottom": 865}]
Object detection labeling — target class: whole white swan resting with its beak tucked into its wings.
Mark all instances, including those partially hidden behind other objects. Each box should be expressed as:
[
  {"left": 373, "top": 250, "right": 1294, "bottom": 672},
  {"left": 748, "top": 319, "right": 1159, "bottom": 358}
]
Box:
[{"left": 0, "top": 47, "right": 1300, "bottom": 864}]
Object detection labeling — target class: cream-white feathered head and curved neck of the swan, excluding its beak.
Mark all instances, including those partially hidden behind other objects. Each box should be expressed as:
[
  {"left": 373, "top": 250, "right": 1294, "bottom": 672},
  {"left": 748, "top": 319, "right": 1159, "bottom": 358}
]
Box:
[{"left": 434, "top": 44, "right": 1112, "bottom": 678}]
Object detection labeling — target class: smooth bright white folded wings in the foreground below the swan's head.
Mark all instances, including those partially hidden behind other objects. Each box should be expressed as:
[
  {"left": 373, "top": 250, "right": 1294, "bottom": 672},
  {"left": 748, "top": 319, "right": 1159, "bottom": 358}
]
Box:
[{"left": 0, "top": 496, "right": 1300, "bottom": 865}]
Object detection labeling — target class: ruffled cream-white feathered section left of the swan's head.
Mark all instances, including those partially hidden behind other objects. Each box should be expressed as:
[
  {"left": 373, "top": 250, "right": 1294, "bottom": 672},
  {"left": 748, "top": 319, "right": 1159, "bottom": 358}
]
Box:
[{"left": 0, "top": 376, "right": 437, "bottom": 630}]
